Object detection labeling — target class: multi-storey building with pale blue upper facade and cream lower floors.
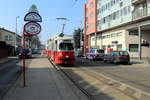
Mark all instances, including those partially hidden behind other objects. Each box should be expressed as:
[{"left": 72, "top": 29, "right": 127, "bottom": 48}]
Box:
[{"left": 85, "top": 0, "right": 150, "bottom": 57}]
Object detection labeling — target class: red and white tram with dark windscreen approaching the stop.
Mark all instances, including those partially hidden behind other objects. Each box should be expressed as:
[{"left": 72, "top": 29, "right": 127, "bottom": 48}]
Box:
[{"left": 46, "top": 34, "right": 75, "bottom": 64}]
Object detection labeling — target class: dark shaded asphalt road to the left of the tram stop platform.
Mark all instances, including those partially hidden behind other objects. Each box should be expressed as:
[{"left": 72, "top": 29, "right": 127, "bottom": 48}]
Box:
[{"left": 0, "top": 58, "right": 21, "bottom": 99}]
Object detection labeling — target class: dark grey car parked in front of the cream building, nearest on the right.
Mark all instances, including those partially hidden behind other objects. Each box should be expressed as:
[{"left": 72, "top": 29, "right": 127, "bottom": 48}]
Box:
[{"left": 104, "top": 51, "right": 130, "bottom": 64}]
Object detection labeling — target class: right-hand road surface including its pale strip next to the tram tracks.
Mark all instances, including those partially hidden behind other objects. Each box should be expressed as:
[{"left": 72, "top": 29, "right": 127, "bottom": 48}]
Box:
[{"left": 76, "top": 58, "right": 150, "bottom": 100}]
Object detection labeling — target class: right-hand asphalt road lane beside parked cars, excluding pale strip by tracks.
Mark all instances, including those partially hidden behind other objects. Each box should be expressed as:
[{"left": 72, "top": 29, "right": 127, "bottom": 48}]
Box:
[{"left": 76, "top": 58, "right": 150, "bottom": 93}]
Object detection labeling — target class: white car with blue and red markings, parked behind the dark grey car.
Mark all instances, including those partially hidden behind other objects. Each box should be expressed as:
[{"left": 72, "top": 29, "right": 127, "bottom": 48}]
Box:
[{"left": 85, "top": 48, "right": 105, "bottom": 60}]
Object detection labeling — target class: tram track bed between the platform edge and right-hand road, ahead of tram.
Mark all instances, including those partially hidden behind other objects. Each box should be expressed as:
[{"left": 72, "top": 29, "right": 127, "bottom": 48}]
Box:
[{"left": 50, "top": 60, "right": 135, "bottom": 100}]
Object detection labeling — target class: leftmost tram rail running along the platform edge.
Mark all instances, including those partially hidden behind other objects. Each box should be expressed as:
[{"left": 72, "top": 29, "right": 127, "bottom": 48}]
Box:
[{"left": 49, "top": 59, "right": 95, "bottom": 100}]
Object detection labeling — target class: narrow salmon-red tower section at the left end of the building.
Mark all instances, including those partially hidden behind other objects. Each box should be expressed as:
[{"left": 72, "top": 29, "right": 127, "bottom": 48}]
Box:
[{"left": 84, "top": 0, "right": 97, "bottom": 51}]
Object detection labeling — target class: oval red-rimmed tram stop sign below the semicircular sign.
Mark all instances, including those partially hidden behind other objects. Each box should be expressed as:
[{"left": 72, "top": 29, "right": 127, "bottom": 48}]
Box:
[{"left": 24, "top": 22, "right": 41, "bottom": 36}]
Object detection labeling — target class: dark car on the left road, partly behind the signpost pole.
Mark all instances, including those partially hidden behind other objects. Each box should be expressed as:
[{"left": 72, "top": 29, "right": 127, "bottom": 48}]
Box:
[{"left": 19, "top": 48, "right": 32, "bottom": 59}]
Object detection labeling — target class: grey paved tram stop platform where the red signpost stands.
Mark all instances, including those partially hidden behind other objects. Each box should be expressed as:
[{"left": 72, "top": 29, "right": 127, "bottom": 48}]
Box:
[{"left": 2, "top": 56, "right": 89, "bottom": 100}]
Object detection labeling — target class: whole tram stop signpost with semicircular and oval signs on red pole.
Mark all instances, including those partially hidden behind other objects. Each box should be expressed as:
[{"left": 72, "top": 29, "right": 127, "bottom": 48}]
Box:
[{"left": 22, "top": 5, "right": 42, "bottom": 87}]
